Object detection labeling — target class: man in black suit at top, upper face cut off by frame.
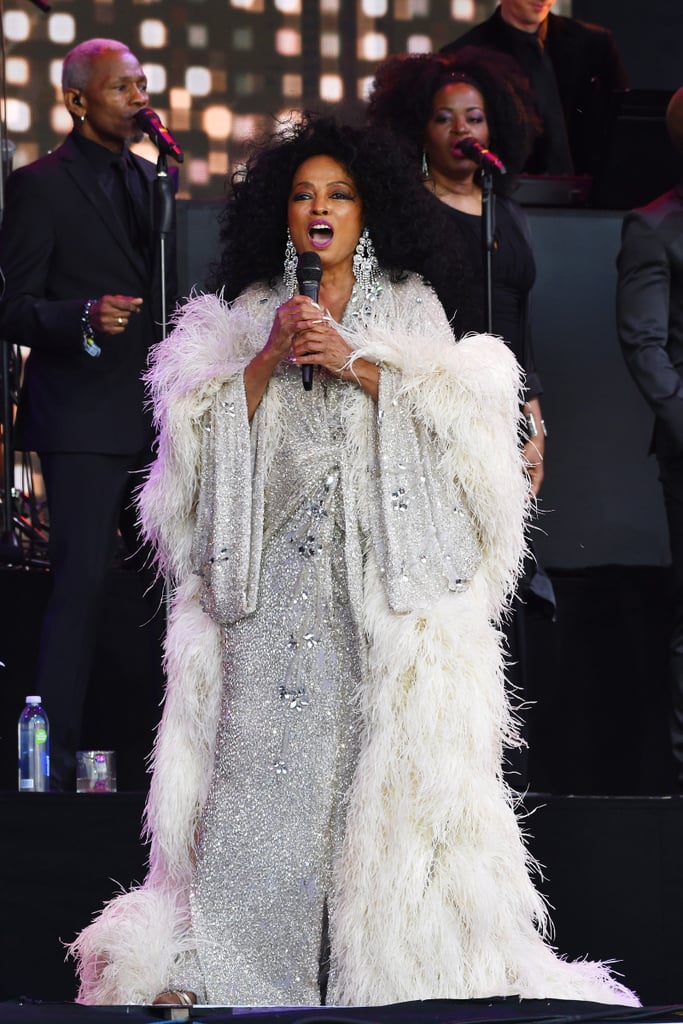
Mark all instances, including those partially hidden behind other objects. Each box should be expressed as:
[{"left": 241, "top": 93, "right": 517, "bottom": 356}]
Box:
[{"left": 441, "top": 0, "right": 627, "bottom": 175}]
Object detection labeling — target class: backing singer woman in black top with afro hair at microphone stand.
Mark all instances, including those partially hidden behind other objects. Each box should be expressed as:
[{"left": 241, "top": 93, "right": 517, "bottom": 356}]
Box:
[{"left": 369, "top": 47, "right": 545, "bottom": 497}]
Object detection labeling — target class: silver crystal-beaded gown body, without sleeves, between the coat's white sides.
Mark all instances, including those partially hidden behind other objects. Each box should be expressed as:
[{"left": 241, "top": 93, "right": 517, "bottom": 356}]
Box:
[{"left": 187, "top": 368, "right": 360, "bottom": 1005}]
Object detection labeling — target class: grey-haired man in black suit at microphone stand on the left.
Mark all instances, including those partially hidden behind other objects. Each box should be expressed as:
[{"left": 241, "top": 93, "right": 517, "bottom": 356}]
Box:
[{"left": 0, "top": 39, "right": 176, "bottom": 788}]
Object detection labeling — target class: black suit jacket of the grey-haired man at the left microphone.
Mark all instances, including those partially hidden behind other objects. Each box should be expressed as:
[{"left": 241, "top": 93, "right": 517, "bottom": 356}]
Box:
[{"left": 0, "top": 136, "right": 177, "bottom": 454}]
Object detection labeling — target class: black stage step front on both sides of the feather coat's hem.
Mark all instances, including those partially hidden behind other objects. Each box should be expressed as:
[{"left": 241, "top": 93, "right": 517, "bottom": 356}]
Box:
[{"left": 0, "top": 793, "right": 683, "bottom": 1007}]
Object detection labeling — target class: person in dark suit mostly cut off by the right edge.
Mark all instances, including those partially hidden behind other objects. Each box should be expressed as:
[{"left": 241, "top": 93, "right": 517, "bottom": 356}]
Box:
[{"left": 616, "top": 88, "right": 683, "bottom": 793}]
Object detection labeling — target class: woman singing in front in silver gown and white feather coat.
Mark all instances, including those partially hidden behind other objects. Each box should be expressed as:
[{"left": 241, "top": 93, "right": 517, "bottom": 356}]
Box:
[{"left": 75, "top": 112, "right": 634, "bottom": 1006}]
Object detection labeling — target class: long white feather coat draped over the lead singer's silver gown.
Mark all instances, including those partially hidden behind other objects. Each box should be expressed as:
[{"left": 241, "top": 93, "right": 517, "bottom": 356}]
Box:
[{"left": 73, "top": 278, "right": 636, "bottom": 1005}]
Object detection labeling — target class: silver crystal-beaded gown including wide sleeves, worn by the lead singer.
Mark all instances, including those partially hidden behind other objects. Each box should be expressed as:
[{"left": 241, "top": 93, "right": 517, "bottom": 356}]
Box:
[{"left": 181, "top": 275, "right": 478, "bottom": 1005}]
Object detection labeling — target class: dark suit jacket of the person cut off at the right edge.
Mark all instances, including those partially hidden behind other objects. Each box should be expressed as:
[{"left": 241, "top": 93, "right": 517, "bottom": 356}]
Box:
[{"left": 616, "top": 183, "right": 683, "bottom": 456}]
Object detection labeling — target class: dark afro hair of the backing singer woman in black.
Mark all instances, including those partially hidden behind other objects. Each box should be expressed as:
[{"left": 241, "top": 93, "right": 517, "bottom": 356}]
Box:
[{"left": 368, "top": 46, "right": 541, "bottom": 186}]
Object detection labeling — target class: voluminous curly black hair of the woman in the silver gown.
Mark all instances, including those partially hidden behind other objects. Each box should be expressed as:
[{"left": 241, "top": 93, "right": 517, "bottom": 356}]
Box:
[{"left": 209, "top": 113, "right": 446, "bottom": 301}]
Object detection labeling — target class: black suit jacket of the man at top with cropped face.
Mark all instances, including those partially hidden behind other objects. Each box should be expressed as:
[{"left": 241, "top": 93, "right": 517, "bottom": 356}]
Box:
[{"left": 441, "top": 7, "right": 627, "bottom": 174}]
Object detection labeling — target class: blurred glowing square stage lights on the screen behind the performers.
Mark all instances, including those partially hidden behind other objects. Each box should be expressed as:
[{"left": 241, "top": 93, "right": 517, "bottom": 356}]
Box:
[{"left": 3, "top": 0, "right": 518, "bottom": 197}]
